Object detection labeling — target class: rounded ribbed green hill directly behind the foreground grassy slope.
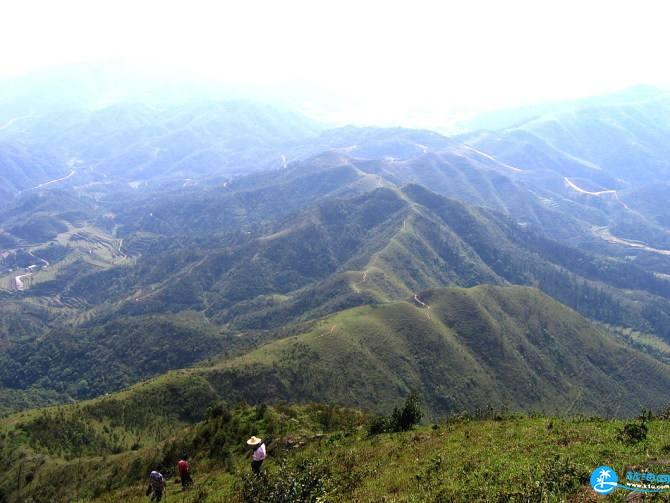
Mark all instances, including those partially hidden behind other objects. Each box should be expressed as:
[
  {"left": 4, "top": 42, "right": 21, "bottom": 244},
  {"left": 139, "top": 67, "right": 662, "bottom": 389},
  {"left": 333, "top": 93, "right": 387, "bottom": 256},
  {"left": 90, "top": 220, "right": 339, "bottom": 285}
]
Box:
[{"left": 206, "top": 286, "right": 670, "bottom": 415}]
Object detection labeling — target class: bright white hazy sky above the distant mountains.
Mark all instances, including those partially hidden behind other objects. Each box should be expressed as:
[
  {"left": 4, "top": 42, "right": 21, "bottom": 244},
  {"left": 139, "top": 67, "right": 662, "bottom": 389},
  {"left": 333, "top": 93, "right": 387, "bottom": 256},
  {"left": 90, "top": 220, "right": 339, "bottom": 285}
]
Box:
[{"left": 0, "top": 0, "right": 670, "bottom": 123}]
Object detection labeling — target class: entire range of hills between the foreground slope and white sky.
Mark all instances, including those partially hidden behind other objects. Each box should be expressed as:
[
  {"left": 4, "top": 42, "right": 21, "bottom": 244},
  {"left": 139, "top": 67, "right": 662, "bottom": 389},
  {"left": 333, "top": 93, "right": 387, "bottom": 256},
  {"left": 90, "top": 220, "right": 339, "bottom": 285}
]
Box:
[{"left": 0, "top": 81, "right": 670, "bottom": 417}]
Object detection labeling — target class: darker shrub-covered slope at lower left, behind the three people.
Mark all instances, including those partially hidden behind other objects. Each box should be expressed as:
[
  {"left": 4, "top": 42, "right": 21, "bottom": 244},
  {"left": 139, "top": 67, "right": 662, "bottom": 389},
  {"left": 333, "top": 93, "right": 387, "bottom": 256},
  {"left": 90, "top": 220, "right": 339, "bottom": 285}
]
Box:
[{"left": 0, "top": 380, "right": 366, "bottom": 503}]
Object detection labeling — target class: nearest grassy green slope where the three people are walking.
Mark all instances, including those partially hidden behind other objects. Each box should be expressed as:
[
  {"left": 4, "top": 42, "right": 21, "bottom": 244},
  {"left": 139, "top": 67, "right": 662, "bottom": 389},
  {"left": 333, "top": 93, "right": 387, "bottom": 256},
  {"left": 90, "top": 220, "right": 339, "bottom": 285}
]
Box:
[{"left": 0, "top": 394, "right": 670, "bottom": 503}]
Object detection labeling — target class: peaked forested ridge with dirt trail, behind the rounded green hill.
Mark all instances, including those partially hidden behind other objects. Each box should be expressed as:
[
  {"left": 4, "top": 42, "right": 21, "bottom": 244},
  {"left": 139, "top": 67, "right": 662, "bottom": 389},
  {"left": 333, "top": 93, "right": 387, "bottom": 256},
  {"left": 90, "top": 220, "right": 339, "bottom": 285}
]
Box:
[{"left": 0, "top": 183, "right": 670, "bottom": 412}]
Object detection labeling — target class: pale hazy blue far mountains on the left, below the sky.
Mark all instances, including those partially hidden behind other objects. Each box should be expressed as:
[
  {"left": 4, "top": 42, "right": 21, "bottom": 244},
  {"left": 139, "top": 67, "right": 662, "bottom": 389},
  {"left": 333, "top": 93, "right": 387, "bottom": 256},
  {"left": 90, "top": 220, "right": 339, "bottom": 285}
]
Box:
[{"left": 0, "top": 101, "right": 322, "bottom": 193}]
